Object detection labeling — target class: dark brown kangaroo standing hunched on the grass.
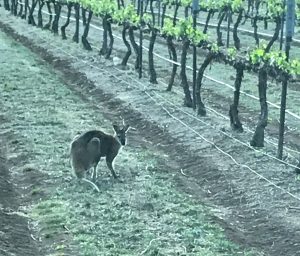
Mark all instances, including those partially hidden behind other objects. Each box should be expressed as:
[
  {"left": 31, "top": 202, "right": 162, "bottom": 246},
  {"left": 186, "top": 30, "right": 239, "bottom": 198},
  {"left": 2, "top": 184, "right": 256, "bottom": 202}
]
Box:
[{"left": 70, "top": 124, "right": 129, "bottom": 192}]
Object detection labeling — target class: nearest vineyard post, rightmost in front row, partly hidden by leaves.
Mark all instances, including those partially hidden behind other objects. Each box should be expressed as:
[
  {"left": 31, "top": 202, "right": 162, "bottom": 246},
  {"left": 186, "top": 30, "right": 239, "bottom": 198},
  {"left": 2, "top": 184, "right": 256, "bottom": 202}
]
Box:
[{"left": 277, "top": 0, "right": 295, "bottom": 159}]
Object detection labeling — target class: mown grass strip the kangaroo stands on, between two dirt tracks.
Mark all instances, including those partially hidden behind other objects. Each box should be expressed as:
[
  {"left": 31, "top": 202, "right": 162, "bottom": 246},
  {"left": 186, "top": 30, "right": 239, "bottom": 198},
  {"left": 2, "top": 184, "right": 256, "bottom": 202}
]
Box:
[{"left": 0, "top": 30, "right": 258, "bottom": 256}]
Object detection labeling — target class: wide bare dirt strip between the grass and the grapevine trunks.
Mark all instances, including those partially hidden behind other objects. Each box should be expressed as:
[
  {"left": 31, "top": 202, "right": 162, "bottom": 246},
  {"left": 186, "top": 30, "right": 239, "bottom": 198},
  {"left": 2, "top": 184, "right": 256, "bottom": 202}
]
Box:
[{"left": 0, "top": 8, "right": 300, "bottom": 256}]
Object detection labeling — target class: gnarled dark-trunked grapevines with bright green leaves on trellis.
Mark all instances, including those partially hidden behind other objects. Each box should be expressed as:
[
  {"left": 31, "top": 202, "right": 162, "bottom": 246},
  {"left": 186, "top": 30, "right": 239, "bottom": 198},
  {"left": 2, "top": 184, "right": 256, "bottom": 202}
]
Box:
[{"left": 4, "top": 0, "right": 300, "bottom": 170}]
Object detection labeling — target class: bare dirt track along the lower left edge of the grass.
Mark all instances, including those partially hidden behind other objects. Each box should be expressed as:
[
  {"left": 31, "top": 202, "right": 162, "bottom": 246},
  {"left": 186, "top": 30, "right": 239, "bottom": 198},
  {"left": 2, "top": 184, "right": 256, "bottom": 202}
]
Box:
[{"left": 0, "top": 117, "right": 39, "bottom": 256}]
